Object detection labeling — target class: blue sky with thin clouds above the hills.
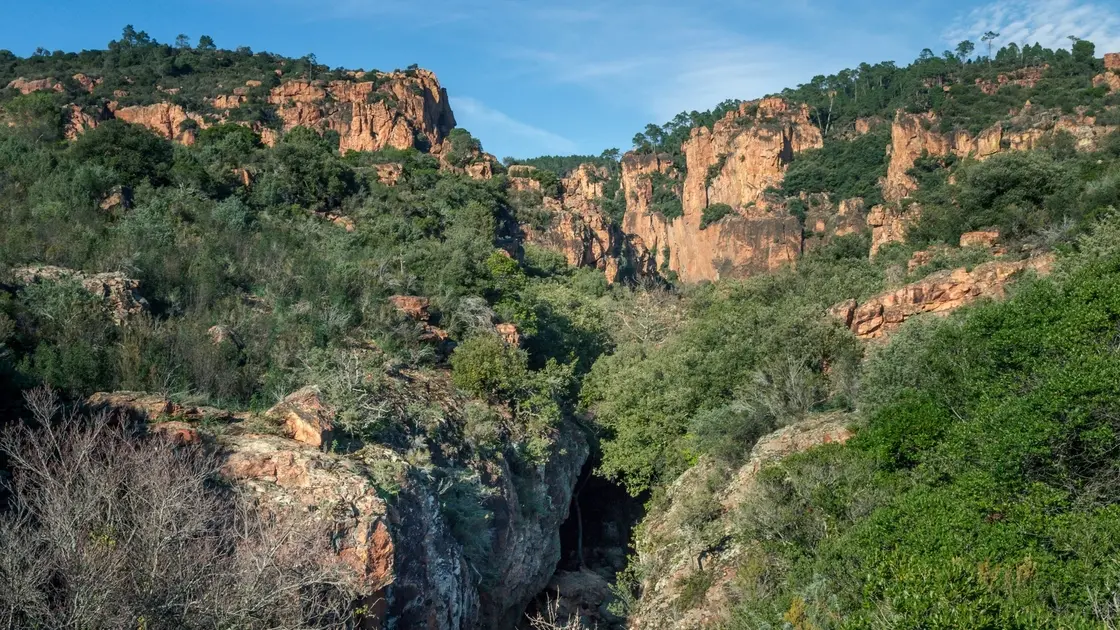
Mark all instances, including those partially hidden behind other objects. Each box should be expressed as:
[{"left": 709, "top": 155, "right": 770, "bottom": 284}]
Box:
[{"left": 0, "top": 0, "right": 1120, "bottom": 157}]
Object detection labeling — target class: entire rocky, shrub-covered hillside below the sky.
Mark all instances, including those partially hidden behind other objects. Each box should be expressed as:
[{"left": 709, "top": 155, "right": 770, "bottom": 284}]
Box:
[{"left": 0, "top": 27, "right": 1120, "bottom": 629}]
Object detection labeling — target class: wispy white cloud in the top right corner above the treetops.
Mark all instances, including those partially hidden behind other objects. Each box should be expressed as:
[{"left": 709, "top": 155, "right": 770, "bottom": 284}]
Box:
[{"left": 944, "top": 0, "right": 1120, "bottom": 55}]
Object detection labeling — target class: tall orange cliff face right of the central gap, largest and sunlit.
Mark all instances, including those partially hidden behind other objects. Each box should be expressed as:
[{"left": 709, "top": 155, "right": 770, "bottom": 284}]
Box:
[{"left": 622, "top": 99, "right": 823, "bottom": 282}]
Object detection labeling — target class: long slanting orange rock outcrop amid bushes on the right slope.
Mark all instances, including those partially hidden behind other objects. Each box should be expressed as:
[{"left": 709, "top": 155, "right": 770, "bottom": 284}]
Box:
[{"left": 830, "top": 256, "right": 1054, "bottom": 340}]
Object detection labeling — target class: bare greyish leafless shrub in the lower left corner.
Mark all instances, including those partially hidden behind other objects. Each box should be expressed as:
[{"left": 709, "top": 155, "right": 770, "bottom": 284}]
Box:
[{"left": 0, "top": 390, "right": 356, "bottom": 630}]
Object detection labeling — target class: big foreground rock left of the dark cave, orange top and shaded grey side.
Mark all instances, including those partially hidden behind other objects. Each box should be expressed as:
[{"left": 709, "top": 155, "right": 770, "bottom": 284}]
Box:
[{"left": 87, "top": 374, "right": 589, "bottom": 630}]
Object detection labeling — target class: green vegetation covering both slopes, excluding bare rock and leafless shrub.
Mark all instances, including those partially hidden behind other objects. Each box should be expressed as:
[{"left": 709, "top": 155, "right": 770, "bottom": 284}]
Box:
[{"left": 0, "top": 29, "right": 1120, "bottom": 629}]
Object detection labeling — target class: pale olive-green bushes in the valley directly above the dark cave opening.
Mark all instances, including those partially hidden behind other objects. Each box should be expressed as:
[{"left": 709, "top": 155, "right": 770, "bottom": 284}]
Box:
[{"left": 581, "top": 248, "right": 883, "bottom": 494}]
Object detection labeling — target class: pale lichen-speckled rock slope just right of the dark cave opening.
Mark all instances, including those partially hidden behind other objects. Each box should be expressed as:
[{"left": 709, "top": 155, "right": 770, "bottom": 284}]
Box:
[{"left": 629, "top": 415, "right": 852, "bottom": 630}]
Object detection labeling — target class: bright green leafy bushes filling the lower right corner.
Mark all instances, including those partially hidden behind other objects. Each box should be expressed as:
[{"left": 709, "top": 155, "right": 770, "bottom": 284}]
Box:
[{"left": 732, "top": 220, "right": 1120, "bottom": 628}]
